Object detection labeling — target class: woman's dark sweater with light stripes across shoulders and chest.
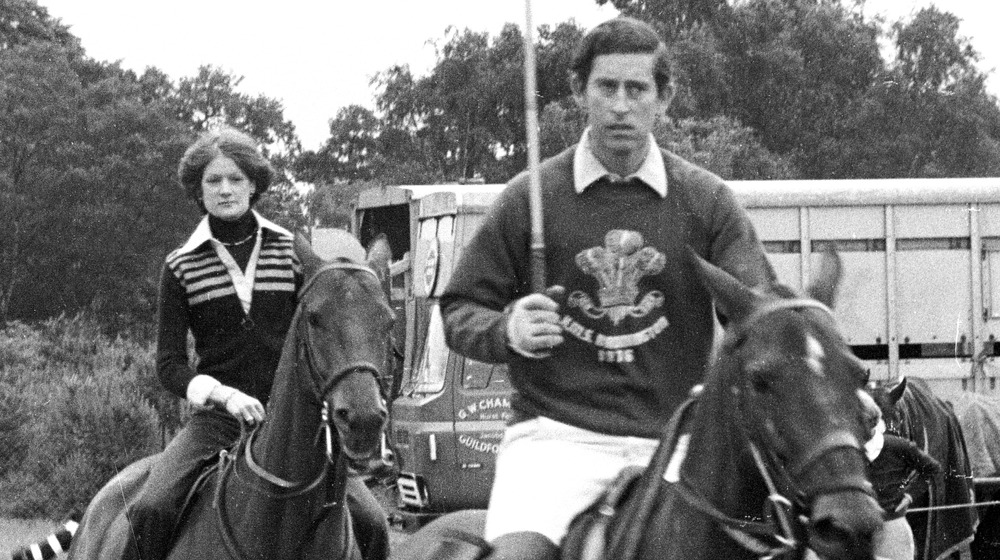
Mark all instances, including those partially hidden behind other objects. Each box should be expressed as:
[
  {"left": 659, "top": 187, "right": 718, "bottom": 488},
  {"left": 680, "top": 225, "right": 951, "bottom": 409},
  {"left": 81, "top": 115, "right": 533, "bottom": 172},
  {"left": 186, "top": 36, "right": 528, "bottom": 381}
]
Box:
[{"left": 156, "top": 212, "right": 302, "bottom": 403}]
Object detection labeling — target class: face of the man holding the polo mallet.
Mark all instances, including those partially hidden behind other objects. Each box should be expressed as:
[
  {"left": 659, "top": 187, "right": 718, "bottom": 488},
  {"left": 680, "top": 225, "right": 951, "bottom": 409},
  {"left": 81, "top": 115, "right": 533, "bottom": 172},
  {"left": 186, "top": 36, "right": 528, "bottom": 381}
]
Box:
[{"left": 576, "top": 53, "right": 670, "bottom": 173}]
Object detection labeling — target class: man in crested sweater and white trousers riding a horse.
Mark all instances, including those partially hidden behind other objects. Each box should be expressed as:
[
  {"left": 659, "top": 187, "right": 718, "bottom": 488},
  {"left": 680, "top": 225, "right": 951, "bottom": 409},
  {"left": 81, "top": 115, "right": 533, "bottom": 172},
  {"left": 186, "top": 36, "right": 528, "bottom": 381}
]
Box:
[{"left": 442, "top": 17, "right": 775, "bottom": 559}]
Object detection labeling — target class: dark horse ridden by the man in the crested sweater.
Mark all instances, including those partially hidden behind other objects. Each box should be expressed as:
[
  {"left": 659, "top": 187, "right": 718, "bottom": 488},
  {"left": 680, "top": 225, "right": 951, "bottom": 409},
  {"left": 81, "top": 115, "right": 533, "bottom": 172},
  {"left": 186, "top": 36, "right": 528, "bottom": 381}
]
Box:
[{"left": 402, "top": 250, "right": 882, "bottom": 560}]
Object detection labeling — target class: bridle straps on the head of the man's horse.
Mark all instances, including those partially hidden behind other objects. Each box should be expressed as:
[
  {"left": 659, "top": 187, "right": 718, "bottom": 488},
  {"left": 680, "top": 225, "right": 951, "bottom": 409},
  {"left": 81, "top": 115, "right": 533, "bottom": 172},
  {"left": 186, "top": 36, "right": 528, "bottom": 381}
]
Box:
[{"left": 675, "top": 298, "right": 874, "bottom": 559}]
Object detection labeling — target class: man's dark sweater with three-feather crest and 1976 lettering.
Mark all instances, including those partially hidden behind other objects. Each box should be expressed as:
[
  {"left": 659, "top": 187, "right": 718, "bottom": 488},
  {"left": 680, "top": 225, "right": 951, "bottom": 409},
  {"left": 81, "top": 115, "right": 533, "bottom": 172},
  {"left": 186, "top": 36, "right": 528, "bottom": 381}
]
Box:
[{"left": 441, "top": 144, "right": 774, "bottom": 438}]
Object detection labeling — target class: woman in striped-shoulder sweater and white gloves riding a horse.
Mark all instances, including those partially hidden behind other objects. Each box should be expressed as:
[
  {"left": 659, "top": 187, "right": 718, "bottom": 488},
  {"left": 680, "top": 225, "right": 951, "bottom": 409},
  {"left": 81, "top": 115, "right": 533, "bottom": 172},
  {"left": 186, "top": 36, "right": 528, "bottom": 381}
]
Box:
[{"left": 126, "top": 129, "right": 388, "bottom": 560}]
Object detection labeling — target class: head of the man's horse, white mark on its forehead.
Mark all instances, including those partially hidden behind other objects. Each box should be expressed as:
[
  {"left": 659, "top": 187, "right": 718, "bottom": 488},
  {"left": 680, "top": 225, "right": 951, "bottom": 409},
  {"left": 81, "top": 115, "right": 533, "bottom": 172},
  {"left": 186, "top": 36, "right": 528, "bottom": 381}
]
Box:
[{"left": 691, "top": 253, "right": 882, "bottom": 560}]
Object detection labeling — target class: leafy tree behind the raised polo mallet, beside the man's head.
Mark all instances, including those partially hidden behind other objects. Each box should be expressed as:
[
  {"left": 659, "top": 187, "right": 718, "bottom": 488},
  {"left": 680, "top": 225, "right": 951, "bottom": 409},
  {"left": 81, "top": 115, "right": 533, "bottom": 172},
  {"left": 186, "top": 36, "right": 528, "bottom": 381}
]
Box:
[{"left": 364, "top": 21, "right": 583, "bottom": 182}]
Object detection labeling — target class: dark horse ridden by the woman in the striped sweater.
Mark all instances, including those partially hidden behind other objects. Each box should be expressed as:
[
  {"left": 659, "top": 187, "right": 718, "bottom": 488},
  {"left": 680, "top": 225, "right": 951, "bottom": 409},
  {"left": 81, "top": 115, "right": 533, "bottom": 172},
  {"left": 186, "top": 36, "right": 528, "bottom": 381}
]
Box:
[{"left": 63, "top": 238, "right": 394, "bottom": 560}]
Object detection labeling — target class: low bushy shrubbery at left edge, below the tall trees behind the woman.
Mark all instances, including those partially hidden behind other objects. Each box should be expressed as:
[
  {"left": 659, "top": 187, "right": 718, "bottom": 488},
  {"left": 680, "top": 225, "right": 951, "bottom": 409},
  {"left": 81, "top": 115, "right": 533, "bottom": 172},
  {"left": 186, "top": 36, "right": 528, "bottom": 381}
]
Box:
[{"left": 0, "top": 316, "right": 181, "bottom": 519}]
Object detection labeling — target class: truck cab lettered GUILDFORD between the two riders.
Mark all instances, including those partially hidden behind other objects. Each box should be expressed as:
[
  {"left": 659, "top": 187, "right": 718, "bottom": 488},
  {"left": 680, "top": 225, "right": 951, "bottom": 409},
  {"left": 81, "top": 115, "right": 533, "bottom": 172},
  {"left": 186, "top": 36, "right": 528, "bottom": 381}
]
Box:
[{"left": 353, "top": 185, "right": 511, "bottom": 520}]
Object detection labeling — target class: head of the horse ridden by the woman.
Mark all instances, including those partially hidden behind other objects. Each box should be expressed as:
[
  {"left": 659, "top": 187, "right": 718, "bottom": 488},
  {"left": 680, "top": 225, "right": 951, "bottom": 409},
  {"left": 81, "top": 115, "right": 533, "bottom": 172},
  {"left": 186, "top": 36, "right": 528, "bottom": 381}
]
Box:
[{"left": 294, "top": 239, "right": 395, "bottom": 470}]
